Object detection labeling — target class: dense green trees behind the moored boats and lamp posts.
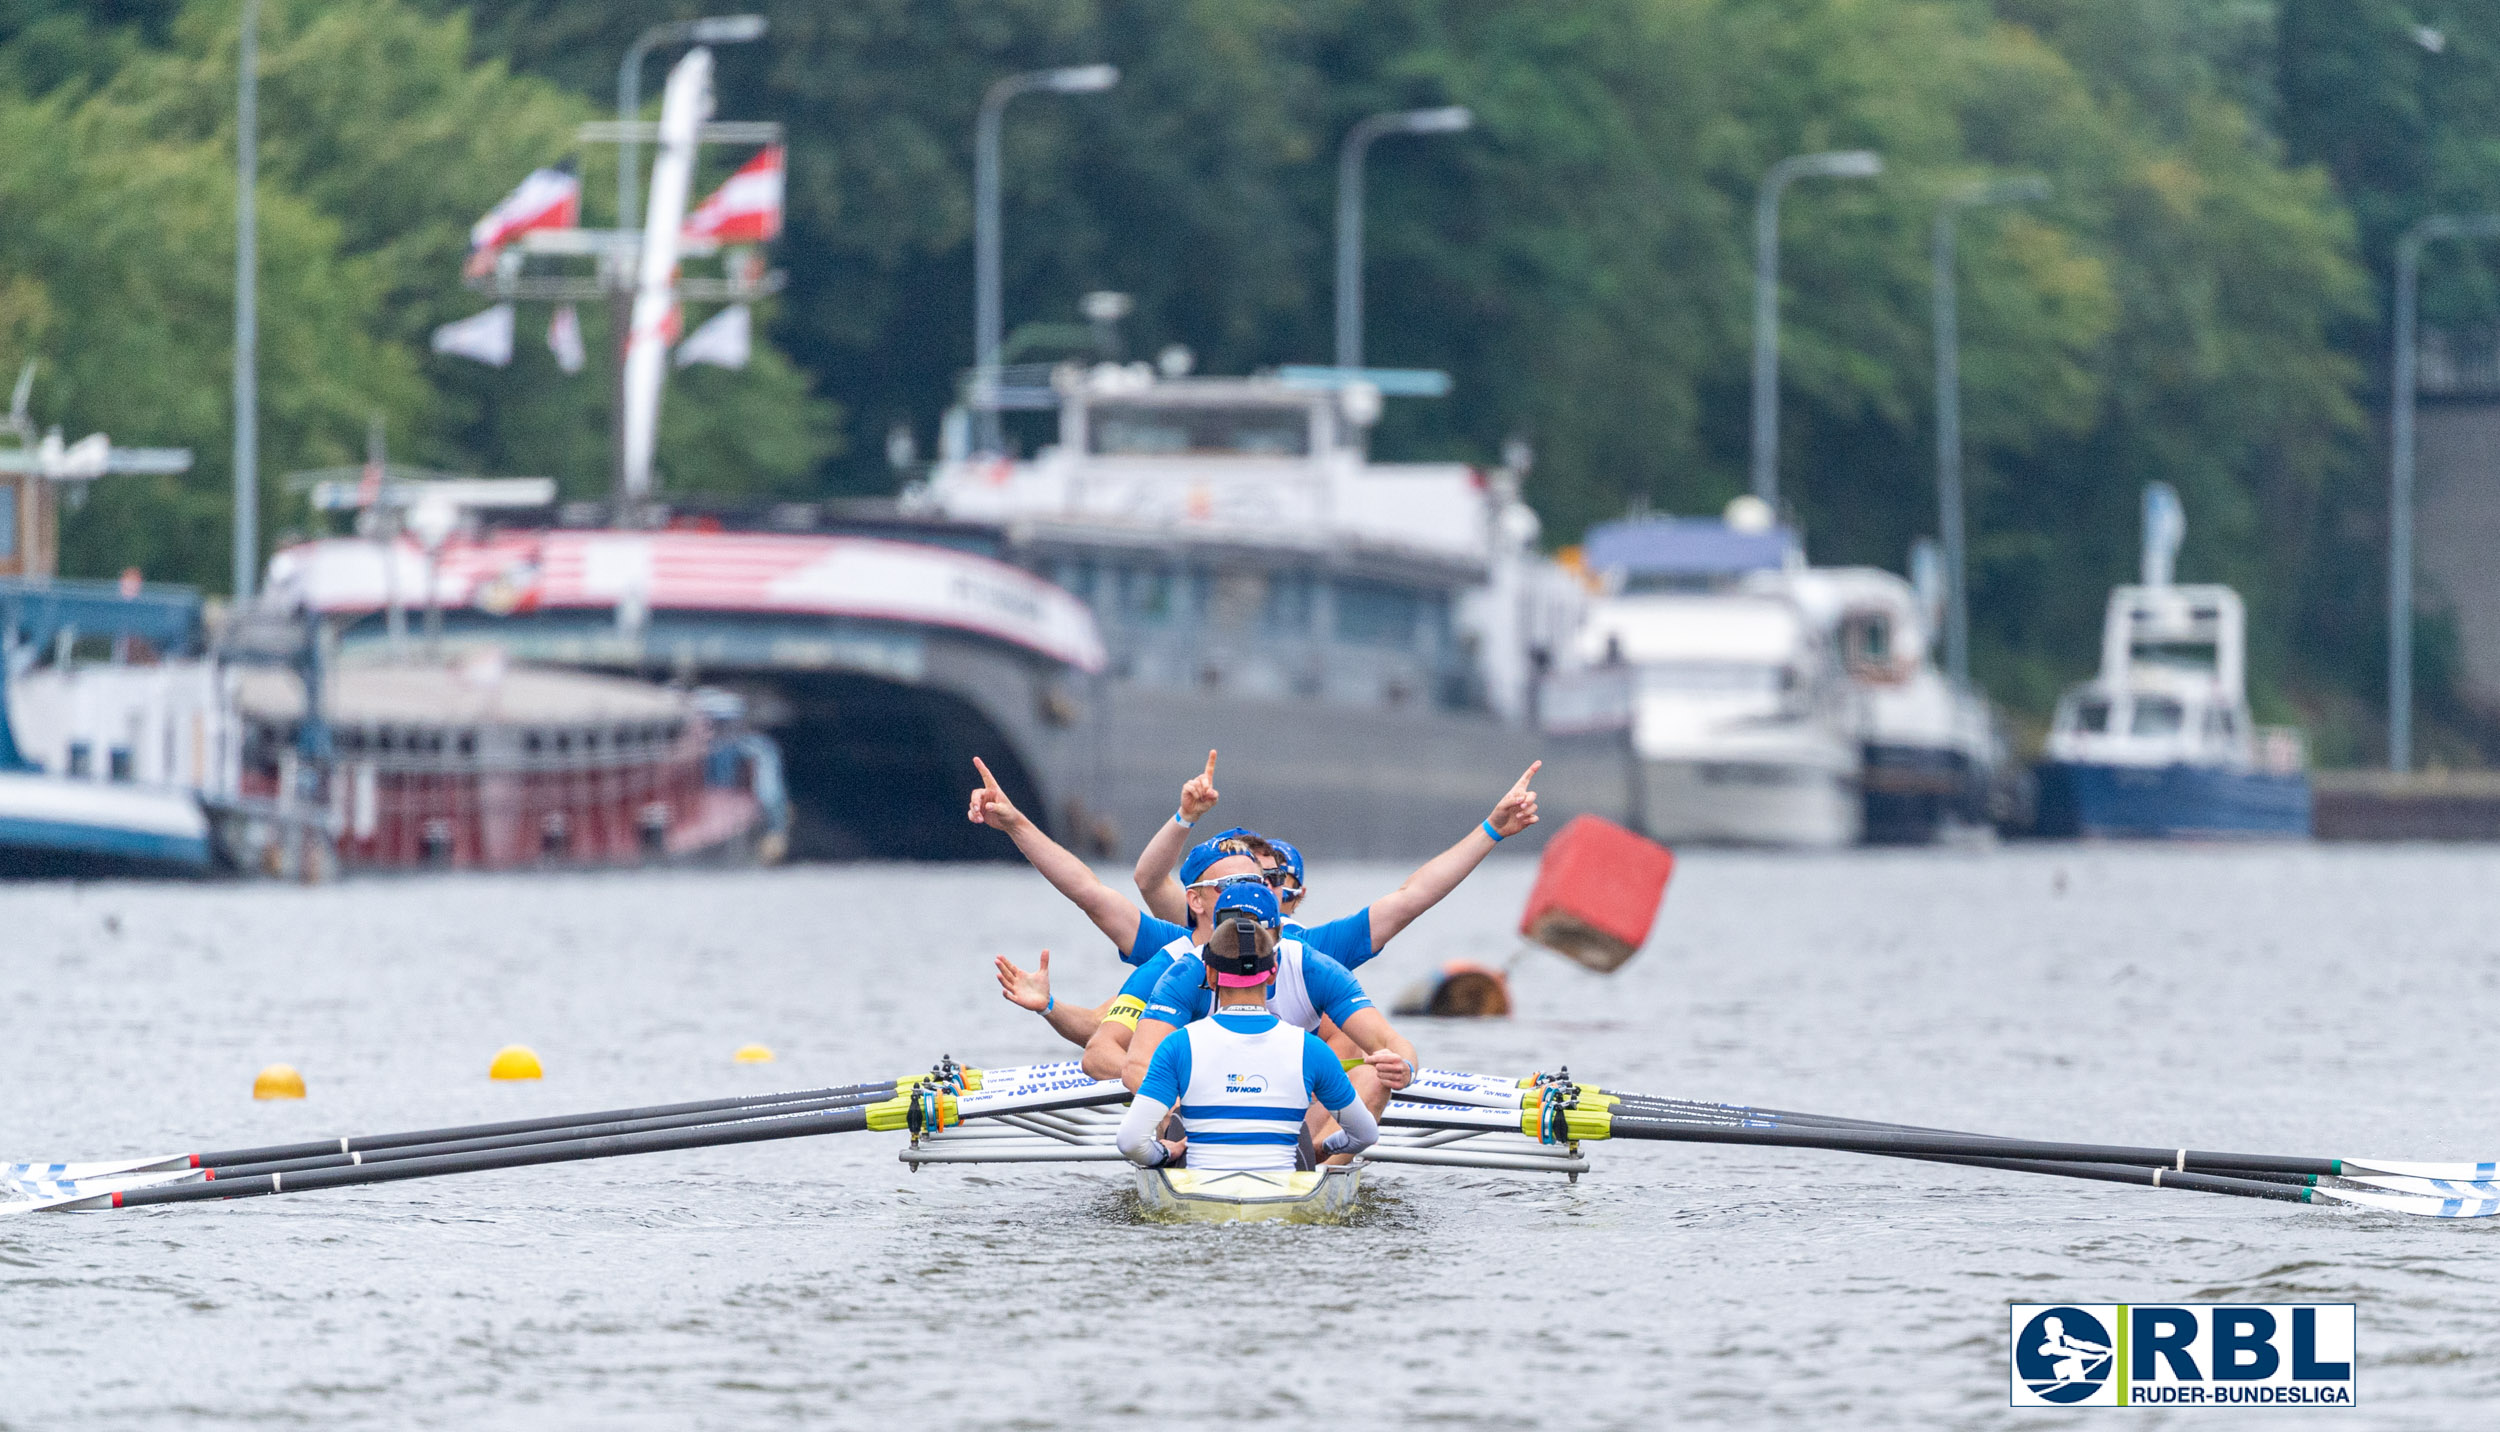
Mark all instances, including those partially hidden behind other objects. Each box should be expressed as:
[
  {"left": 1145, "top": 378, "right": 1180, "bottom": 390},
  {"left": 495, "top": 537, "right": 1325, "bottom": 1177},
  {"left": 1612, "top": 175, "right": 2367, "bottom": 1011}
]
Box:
[{"left": 0, "top": 0, "right": 2500, "bottom": 757}]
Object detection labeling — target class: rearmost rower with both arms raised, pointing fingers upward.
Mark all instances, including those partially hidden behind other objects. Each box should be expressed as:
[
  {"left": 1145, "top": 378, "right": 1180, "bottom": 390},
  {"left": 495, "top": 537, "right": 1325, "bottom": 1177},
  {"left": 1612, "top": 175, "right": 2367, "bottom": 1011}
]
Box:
[{"left": 1135, "top": 750, "right": 1545, "bottom": 970}]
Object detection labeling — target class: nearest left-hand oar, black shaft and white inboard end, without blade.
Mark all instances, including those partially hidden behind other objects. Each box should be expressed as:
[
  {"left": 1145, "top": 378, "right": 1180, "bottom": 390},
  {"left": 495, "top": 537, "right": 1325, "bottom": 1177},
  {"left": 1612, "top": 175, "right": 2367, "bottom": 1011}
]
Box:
[{"left": 97, "top": 1080, "right": 1130, "bottom": 1207}]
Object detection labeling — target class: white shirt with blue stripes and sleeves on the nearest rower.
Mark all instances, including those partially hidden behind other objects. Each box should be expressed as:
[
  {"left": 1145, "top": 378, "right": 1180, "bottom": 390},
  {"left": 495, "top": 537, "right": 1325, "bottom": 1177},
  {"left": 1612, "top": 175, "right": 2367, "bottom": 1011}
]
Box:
[{"left": 1120, "top": 1005, "right": 1380, "bottom": 1172}]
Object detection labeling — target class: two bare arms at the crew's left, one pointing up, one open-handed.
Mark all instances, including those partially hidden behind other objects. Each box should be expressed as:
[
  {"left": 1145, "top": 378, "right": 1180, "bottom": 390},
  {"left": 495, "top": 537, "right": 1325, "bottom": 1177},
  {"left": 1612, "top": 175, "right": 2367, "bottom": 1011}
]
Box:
[{"left": 968, "top": 757, "right": 1190, "bottom": 1080}]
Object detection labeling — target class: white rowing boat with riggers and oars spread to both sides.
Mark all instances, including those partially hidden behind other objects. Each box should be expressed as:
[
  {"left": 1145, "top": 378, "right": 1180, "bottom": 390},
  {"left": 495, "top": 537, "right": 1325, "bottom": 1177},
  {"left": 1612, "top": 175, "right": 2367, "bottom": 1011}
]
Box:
[{"left": 0, "top": 1060, "right": 2500, "bottom": 1222}]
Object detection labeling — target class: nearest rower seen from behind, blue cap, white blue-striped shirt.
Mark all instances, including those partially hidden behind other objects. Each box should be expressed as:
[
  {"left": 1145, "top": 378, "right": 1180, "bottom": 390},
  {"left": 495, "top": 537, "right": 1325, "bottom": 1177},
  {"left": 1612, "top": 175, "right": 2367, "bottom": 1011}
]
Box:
[{"left": 1120, "top": 880, "right": 1380, "bottom": 1172}]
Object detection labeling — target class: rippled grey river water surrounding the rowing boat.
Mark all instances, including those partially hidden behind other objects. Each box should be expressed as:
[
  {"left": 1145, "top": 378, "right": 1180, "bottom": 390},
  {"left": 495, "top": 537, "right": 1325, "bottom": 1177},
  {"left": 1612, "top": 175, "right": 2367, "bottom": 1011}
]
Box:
[{"left": 0, "top": 847, "right": 2500, "bottom": 1430}]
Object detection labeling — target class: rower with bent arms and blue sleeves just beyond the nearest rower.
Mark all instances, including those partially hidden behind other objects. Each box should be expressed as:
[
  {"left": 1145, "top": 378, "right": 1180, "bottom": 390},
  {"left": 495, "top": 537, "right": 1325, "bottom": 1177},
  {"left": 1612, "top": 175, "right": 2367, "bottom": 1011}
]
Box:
[{"left": 1120, "top": 855, "right": 1415, "bottom": 1159}]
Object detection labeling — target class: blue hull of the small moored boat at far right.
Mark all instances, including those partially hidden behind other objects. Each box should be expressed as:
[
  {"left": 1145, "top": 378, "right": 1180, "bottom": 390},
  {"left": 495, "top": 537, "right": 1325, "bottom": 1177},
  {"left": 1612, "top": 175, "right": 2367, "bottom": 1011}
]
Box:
[{"left": 2035, "top": 760, "right": 2310, "bottom": 840}]
